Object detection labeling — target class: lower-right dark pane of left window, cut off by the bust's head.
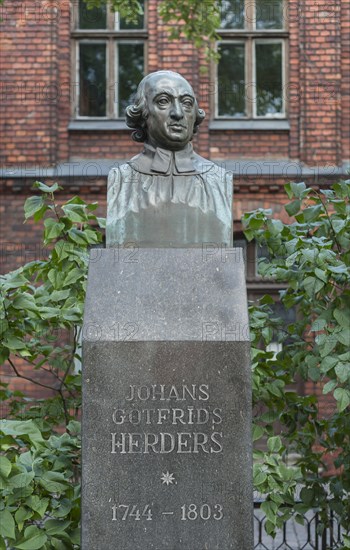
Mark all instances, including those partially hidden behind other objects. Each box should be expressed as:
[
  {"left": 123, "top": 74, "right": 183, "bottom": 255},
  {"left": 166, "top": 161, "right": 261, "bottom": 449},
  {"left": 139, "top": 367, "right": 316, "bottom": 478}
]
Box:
[{"left": 118, "top": 44, "right": 144, "bottom": 116}]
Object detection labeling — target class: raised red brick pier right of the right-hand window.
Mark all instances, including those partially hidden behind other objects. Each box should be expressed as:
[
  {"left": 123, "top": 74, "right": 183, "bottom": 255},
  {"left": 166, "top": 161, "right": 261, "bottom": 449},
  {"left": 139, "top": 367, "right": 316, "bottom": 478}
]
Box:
[{"left": 299, "top": 0, "right": 341, "bottom": 165}]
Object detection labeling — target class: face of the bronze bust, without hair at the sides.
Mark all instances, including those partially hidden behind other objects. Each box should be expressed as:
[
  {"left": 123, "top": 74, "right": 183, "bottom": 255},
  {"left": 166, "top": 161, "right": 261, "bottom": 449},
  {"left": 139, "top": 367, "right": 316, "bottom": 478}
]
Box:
[{"left": 145, "top": 74, "right": 196, "bottom": 151}]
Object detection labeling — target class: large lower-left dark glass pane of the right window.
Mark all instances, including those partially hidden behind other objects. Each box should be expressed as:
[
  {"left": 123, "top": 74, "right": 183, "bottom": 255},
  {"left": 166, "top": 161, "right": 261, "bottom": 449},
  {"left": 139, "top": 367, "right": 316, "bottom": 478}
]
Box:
[{"left": 218, "top": 44, "right": 246, "bottom": 117}]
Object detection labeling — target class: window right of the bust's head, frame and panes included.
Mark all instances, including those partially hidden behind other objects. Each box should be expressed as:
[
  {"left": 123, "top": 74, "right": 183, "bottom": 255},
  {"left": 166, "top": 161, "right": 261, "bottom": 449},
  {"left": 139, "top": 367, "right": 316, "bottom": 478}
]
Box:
[{"left": 215, "top": 0, "right": 288, "bottom": 119}]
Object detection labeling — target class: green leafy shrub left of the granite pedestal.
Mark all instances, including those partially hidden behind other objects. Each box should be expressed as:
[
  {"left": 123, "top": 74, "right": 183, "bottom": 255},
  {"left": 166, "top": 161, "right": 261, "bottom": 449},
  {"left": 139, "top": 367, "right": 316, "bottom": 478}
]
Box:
[{"left": 0, "top": 182, "right": 104, "bottom": 550}]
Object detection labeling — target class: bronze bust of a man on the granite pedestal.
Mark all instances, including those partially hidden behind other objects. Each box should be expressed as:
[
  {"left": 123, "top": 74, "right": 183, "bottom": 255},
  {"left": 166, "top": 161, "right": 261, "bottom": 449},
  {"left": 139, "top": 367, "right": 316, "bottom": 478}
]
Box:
[{"left": 106, "top": 71, "right": 232, "bottom": 248}]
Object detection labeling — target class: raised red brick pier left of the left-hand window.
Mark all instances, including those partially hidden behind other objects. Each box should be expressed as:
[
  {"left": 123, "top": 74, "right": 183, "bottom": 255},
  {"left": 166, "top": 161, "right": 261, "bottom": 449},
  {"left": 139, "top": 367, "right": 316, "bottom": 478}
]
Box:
[{"left": 0, "top": 0, "right": 58, "bottom": 164}]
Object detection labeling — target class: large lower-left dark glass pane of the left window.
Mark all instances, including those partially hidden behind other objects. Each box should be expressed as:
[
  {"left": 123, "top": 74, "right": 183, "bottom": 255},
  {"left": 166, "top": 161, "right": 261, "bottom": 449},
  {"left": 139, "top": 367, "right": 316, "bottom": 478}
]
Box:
[{"left": 79, "top": 44, "right": 106, "bottom": 116}]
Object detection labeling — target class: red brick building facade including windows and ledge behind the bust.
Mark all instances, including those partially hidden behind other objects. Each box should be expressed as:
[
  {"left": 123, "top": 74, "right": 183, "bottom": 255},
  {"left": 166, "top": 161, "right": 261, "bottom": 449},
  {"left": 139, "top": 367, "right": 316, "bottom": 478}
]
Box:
[{"left": 0, "top": 0, "right": 350, "bottom": 410}]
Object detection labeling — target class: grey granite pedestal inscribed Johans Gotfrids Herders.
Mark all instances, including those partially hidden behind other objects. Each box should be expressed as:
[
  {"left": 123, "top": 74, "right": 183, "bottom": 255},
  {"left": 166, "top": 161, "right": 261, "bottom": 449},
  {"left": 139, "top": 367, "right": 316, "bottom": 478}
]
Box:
[{"left": 82, "top": 246, "right": 253, "bottom": 550}]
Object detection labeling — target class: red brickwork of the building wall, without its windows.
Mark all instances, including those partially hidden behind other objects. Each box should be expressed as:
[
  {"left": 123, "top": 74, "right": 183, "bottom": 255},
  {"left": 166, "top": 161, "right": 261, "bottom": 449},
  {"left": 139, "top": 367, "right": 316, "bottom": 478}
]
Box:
[{"left": 0, "top": 0, "right": 350, "bottom": 410}]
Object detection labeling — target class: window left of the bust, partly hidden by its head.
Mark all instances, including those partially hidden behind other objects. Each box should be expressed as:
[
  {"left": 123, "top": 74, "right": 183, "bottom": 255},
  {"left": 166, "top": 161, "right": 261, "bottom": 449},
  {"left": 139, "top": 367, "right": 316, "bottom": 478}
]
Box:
[{"left": 72, "top": 0, "right": 147, "bottom": 119}]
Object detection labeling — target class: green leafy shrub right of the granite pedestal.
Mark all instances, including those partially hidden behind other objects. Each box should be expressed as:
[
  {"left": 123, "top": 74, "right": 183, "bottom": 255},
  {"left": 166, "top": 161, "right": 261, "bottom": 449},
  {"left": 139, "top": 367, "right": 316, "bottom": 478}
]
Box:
[{"left": 243, "top": 181, "right": 350, "bottom": 533}]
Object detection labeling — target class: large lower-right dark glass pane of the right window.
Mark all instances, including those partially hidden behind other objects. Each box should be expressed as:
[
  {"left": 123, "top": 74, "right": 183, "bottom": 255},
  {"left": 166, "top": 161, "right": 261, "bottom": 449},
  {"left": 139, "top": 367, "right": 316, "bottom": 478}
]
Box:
[{"left": 255, "top": 43, "right": 283, "bottom": 116}]
